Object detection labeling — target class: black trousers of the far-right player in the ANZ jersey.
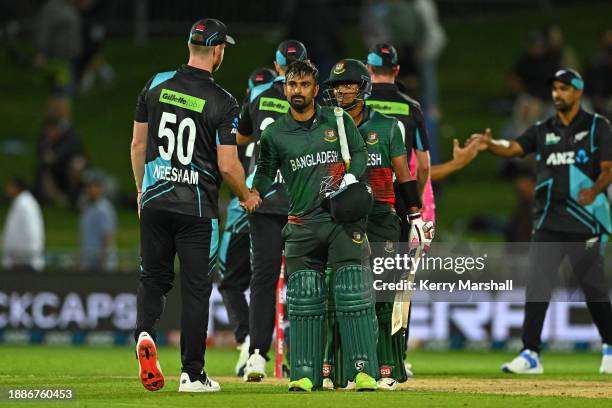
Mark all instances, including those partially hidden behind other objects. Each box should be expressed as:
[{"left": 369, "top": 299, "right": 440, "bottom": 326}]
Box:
[{"left": 523, "top": 230, "right": 612, "bottom": 353}]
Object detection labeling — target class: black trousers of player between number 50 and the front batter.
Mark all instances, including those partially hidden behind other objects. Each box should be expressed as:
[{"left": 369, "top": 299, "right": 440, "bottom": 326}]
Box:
[{"left": 249, "top": 213, "right": 287, "bottom": 360}]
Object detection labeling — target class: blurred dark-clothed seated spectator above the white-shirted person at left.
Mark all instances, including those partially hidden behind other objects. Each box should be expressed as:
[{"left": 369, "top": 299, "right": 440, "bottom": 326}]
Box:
[{"left": 36, "top": 117, "right": 87, "bottom": 206}]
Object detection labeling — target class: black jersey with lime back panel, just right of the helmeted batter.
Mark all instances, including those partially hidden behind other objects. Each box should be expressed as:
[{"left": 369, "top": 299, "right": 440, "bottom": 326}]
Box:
[{"left": 366, "top": 84, "right": 429, "bottom": 155}]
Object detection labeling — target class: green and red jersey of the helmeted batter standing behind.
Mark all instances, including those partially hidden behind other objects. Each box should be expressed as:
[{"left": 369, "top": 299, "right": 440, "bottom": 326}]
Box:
[{"left": 359, "top": 107, "right": 406, "bottom": 214}]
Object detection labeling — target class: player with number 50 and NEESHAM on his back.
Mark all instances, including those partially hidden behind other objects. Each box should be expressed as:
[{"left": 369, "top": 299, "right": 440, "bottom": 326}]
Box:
[{"left": 131, "top": 19, "right": 260, "bottom": 392}]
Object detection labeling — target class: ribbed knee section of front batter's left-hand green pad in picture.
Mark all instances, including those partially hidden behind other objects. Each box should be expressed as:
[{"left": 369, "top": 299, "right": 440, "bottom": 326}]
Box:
[{"left": 287, "top": 270, "right": 325, "bottom": 316}]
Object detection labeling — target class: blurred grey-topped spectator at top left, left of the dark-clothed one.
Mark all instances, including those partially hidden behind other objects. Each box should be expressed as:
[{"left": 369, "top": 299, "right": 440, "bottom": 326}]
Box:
[{"left": 33, "top": 0, "right": 81, "bottom": 119}]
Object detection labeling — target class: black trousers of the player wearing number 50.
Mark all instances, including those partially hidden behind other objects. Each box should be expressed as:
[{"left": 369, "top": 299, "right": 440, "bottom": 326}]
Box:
[{"left": 134, "top": 207, "right": 217, "bottom": 378}]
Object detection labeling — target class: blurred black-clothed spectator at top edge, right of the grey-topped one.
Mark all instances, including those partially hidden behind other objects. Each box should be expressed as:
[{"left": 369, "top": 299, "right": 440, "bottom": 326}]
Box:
[{"left": 76, "top": 0, "right": 115, "bottom": 92}]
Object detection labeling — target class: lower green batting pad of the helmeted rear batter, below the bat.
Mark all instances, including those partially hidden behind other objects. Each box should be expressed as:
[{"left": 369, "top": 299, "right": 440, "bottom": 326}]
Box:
[{"left": 376, "top": 303, "right": 408, "bottom": 383}]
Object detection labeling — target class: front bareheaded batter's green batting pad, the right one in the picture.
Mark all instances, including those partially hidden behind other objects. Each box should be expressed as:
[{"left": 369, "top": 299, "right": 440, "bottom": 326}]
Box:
[{"left": 334, "top": 265, "right": 378, "bottom": 379}]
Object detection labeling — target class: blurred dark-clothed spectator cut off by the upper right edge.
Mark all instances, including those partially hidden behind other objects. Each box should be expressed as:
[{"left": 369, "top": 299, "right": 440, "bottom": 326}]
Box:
[{"left": 585, "top": 29, "right": 612, "bottom": 119}]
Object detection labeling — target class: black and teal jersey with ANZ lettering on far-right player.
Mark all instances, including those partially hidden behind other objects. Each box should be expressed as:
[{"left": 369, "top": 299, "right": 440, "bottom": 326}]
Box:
[{"left": 516, "top": 109, "right": 612, "bottom": 236}]
